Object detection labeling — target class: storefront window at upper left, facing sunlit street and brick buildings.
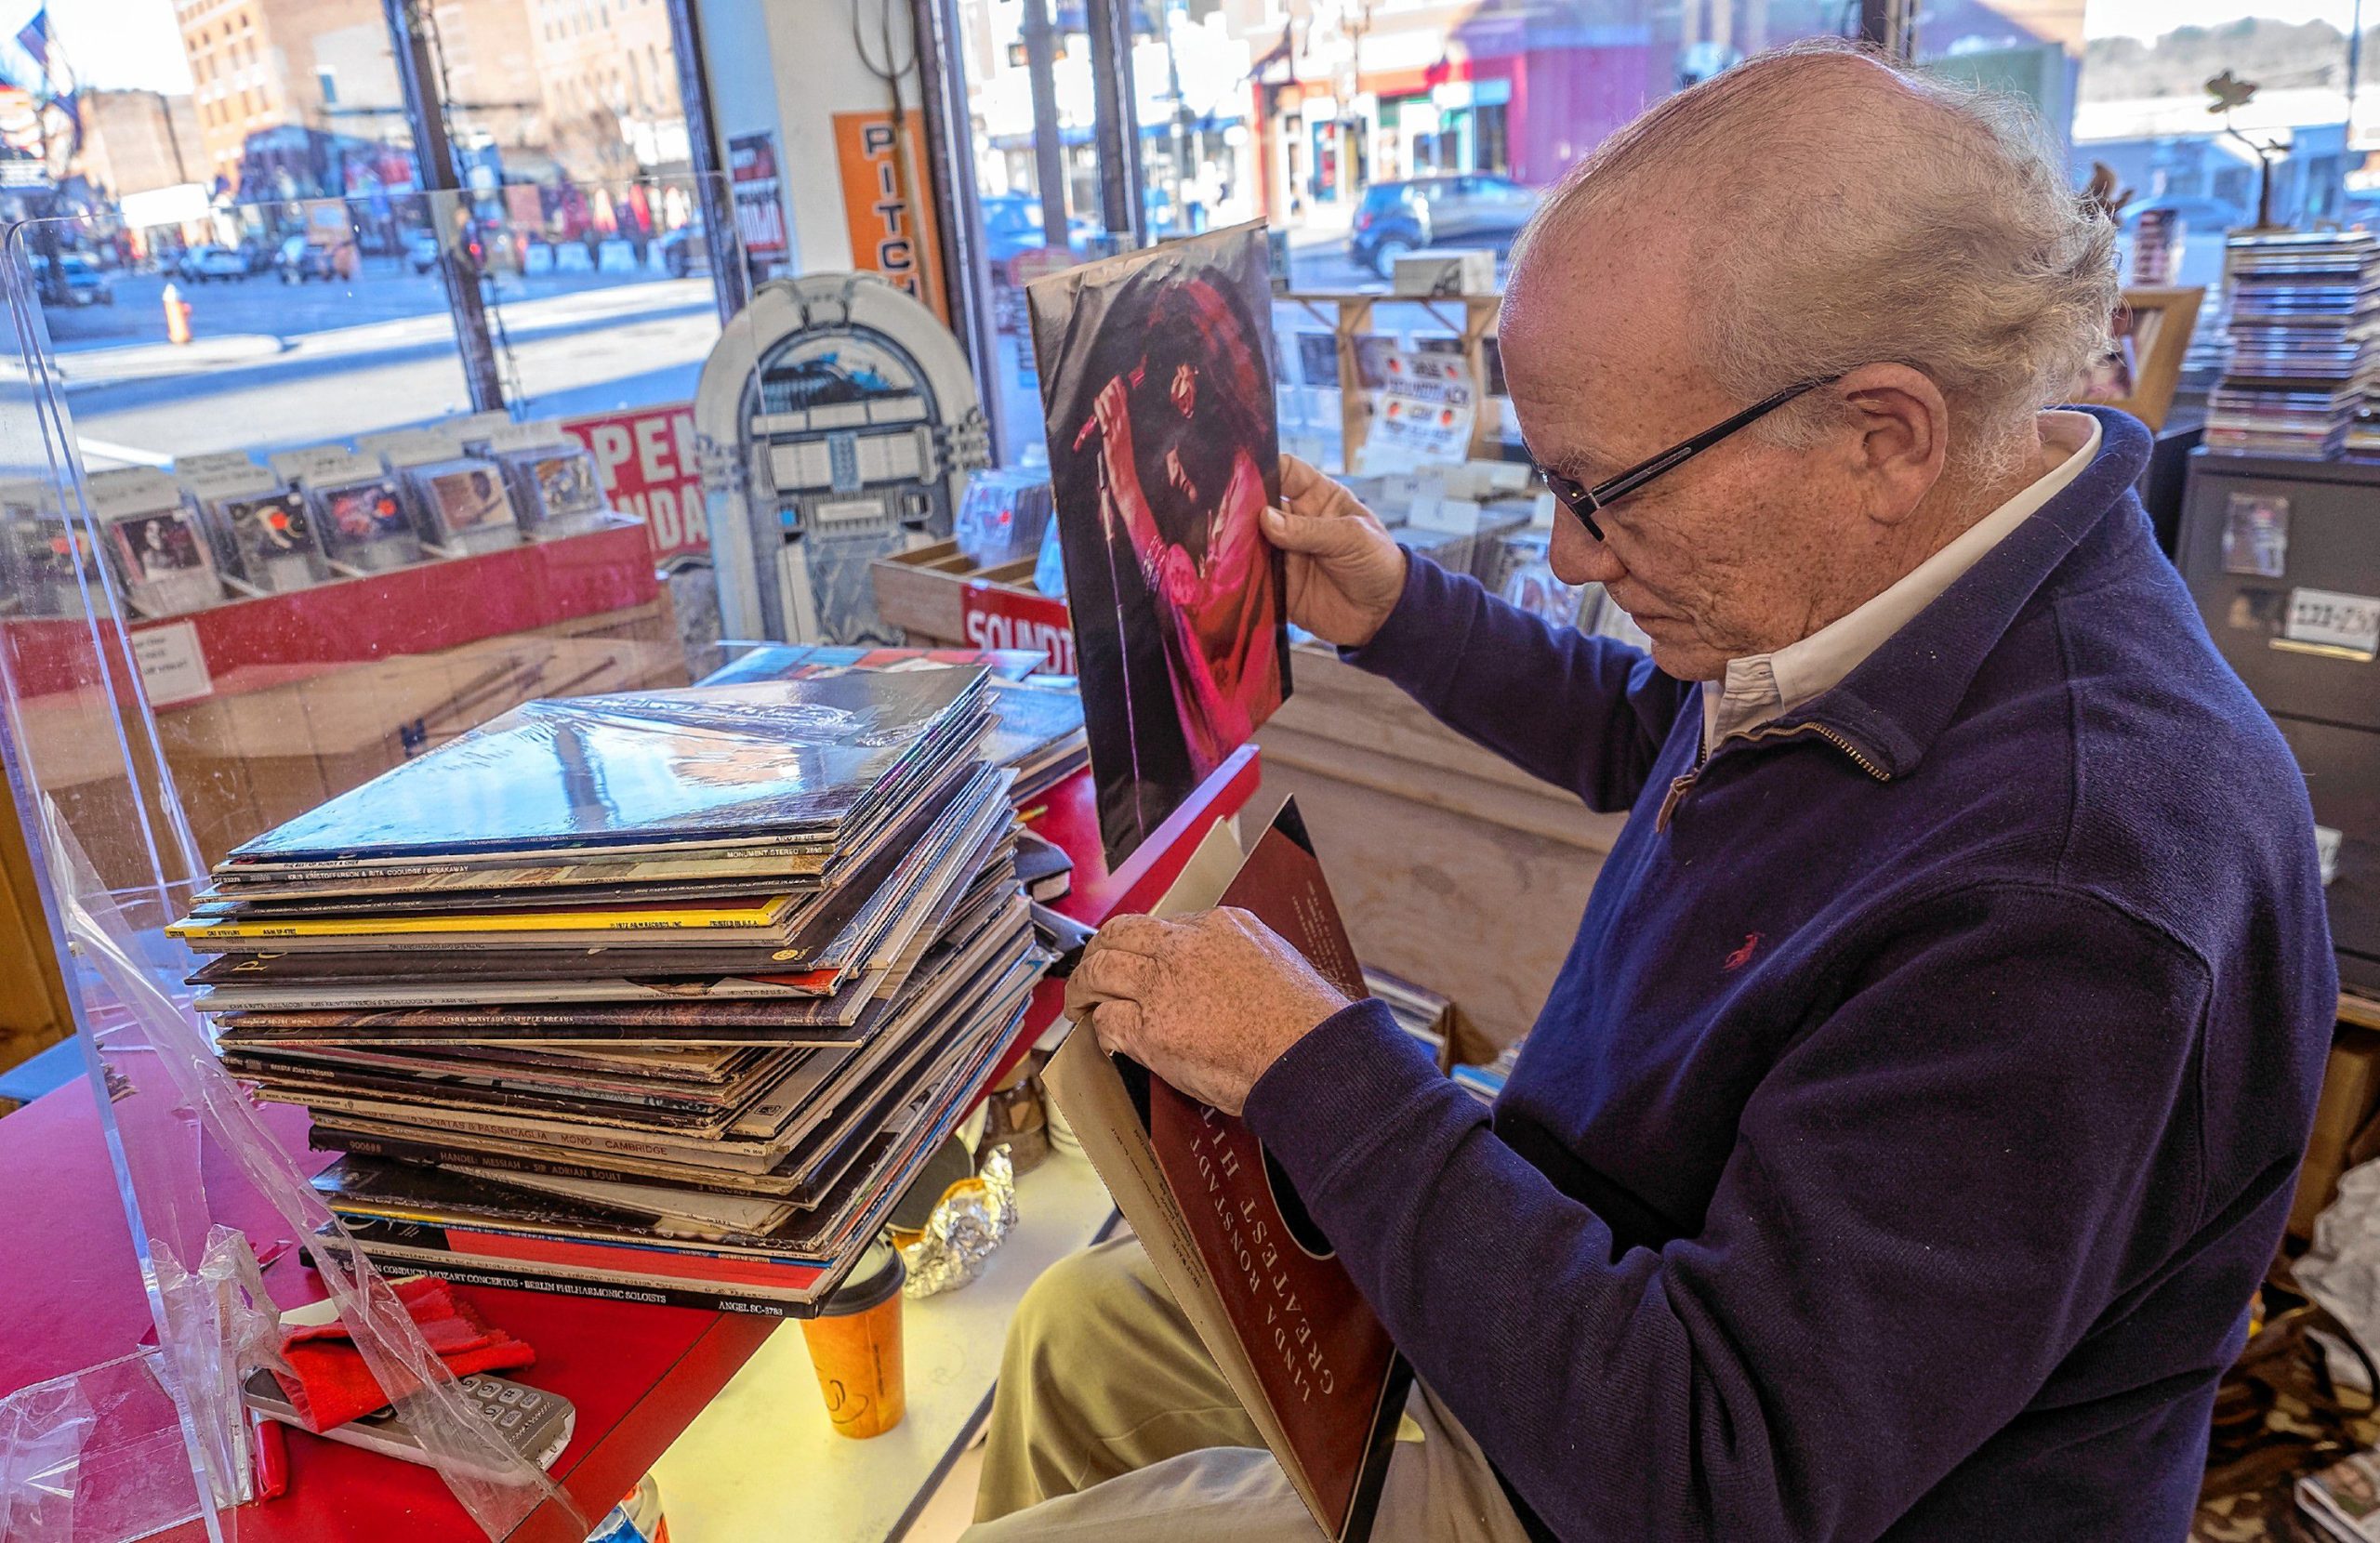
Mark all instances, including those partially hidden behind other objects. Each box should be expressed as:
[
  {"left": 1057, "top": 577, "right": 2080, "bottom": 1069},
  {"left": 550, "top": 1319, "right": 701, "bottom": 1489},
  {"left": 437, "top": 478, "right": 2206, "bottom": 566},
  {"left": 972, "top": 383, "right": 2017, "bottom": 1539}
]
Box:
[{"left": 28, "top": 0, "right": 719, "bottom": 450}]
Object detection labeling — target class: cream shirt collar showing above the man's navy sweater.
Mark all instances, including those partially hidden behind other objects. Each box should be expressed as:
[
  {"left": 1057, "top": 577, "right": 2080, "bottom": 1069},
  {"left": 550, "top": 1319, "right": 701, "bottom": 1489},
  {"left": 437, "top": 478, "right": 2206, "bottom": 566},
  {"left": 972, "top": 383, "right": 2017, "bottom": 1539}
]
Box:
[{"left": 1701, "top": 412, "right": 2099, "bottom": 747}]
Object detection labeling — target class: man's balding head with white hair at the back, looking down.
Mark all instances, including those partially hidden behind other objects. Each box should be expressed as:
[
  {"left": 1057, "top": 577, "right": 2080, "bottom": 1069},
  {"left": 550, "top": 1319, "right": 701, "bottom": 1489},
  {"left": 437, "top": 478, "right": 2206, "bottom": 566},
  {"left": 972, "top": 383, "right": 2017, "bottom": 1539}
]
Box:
[{"left": 1500, "top": 46, "right": 2116, "bottom": 679}]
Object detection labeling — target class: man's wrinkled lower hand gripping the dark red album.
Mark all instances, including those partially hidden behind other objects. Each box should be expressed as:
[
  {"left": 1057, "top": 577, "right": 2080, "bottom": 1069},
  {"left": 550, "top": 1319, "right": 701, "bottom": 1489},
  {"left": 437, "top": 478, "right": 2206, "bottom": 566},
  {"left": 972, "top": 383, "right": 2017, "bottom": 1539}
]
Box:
[{"left": 1066, "top": 907, "right": 1350, "bottom": 1114}]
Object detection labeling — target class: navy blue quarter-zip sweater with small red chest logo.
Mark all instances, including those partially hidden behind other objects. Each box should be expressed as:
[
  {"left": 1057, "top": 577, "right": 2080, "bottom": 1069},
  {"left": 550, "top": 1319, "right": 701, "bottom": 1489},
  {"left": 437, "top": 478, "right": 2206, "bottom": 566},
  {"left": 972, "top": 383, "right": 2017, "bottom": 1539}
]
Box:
[{"left": 1247, "top": 412, "right": 2337, "bottom": 1543}]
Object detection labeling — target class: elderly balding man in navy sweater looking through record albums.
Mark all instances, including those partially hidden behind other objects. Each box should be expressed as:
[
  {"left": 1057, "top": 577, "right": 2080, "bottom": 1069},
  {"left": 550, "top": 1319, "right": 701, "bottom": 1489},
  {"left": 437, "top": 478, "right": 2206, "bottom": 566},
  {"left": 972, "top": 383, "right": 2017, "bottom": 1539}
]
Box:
[{"left": 978, "top": 47, "right": 2334, "bottom": 1543}]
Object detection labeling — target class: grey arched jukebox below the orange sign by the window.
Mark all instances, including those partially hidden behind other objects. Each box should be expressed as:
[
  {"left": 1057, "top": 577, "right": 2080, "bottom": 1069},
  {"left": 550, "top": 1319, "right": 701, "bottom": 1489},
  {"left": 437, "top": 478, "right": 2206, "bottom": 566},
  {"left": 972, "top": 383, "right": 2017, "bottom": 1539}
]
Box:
[{"left": 695, "top": 274, "right": 990, "bottom": 643}]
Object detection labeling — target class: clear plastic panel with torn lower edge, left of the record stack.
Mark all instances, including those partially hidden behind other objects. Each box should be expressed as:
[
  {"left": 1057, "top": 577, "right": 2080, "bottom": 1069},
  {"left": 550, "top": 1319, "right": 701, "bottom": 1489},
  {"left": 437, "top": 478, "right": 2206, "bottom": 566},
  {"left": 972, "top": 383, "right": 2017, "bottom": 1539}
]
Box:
[{"left": 0, "top": 183, "right": 719, "bottom": 1543}]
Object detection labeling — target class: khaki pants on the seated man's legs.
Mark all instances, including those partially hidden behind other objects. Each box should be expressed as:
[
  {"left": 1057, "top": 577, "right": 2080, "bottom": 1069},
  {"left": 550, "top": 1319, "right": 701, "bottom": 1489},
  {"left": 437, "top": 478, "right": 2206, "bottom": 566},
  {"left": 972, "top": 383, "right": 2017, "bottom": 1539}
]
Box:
[{"left": 966, "top": 1238, "right": 1526, "bottom": 1543}]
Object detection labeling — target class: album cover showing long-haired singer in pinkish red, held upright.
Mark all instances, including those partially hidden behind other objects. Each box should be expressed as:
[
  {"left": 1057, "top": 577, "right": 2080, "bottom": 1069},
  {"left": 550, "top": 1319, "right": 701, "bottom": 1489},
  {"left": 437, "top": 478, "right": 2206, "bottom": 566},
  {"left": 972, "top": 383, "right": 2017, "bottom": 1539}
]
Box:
[{"left": 1025, "top": 224, "right": 1290, "bottom": 864}]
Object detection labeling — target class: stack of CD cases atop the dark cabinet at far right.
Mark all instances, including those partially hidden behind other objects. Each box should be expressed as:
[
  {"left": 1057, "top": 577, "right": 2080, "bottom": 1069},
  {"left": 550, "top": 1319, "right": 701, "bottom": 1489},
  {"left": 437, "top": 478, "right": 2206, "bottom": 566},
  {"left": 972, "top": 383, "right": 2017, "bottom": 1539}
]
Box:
[{"left": 2206, "top": 231, "right": 2380, "bottom": 459}]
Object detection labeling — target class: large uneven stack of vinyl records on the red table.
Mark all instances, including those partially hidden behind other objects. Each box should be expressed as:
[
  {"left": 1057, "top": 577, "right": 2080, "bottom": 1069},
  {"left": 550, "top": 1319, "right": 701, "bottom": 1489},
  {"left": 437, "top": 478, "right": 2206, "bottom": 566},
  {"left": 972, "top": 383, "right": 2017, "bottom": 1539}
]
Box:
[{"left": 174, "top": 669, "right": 1045, "bottom": 1314}]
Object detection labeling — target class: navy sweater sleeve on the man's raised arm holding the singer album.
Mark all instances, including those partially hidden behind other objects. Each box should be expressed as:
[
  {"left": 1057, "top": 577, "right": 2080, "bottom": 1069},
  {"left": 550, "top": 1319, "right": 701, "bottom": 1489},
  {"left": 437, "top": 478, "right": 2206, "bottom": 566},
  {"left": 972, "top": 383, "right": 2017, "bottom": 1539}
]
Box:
[{"left": 1342, "top": 550, "right": 1695, "bottom": 812}]
